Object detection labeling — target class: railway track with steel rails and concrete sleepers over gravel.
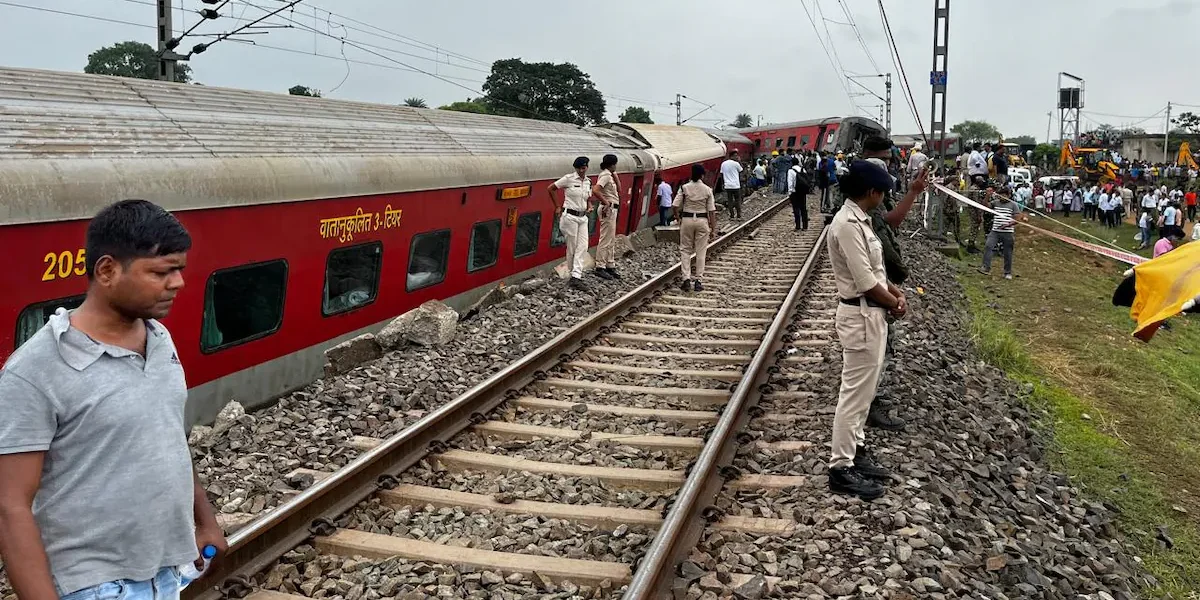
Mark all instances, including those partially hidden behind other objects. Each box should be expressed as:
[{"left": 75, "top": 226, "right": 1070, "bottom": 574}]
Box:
[{"left": 185, "top": 202, "right": 833, "bottom": 600}]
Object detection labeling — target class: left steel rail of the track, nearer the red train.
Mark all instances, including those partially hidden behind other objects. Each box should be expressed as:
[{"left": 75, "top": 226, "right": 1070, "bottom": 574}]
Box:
[{"left": 182, "top": 199, "right": 788, "bottom": 600}]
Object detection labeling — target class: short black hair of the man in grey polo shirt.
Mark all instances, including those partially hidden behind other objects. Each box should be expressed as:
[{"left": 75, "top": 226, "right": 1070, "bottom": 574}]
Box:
[{"left": 85, "top": 200, "right": 192, "bottom": 280}]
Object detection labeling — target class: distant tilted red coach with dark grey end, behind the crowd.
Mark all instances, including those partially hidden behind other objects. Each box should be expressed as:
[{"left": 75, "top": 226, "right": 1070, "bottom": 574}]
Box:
[{"left": 738, "top": 116, "right": 887, "bottom": 155}]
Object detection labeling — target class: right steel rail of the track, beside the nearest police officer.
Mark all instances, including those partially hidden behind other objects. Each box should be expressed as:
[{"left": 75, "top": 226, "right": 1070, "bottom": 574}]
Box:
[{"left": 622, "top": 228, "right": 829, "bottom": 600}]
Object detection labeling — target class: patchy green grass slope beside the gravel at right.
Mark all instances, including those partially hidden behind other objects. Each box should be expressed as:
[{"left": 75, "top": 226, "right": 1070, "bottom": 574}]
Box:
[{"left": 959, "top": 228, "right": 1200, "bottom": 599}]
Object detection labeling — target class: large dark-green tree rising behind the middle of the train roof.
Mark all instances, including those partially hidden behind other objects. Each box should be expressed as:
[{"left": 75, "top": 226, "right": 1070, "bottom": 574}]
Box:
[{"left": 484, "top": 59, "right": 605, "bottom": 125}]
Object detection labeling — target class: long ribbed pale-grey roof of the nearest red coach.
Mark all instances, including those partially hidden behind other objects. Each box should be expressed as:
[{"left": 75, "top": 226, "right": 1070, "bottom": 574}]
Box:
[{"left": 0, "top": 68, "right": 656, "bottom": 224}]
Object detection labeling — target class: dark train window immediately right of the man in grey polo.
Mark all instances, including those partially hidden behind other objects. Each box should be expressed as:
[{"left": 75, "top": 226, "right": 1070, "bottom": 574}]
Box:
[{"left": 200, "top": 260, "right": 288, "bottom": 353}]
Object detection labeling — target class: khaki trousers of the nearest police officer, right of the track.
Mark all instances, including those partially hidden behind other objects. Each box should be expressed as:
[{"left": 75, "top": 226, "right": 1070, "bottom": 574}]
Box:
[{"left": 829, "top": 304, "right": 888, "bottom": 468}]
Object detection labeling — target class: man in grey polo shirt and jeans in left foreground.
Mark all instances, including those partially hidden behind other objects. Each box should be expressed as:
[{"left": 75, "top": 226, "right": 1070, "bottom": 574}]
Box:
[{"left": 0, "top": 200, "right": 226, "bottom": 600}]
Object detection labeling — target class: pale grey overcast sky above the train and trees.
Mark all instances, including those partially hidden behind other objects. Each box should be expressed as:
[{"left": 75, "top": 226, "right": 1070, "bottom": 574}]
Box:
[{"left": 0, "top": 0, "right": 1200, "bottom": 140}]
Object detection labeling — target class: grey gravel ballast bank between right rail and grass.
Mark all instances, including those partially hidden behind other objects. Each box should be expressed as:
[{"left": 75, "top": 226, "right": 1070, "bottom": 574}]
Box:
[{"left": 679, "top": 231, "right": 1152, "bottom": 600}]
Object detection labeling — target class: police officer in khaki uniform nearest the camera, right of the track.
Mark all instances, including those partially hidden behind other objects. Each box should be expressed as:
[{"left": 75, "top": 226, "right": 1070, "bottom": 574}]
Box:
[{"left": 827, "top": 161, "right": 926, "bottom": 500}]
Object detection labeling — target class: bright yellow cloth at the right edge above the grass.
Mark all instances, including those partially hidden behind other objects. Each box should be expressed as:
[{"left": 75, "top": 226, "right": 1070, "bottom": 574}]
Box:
[{"left": 1129, "top": 242, "right": 1200, "bottom": 340}]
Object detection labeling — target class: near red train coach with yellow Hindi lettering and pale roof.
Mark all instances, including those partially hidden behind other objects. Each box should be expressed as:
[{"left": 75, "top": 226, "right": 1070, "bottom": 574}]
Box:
[{"left": 0, "top": 68, "right": 724, "bottom": 422}]
